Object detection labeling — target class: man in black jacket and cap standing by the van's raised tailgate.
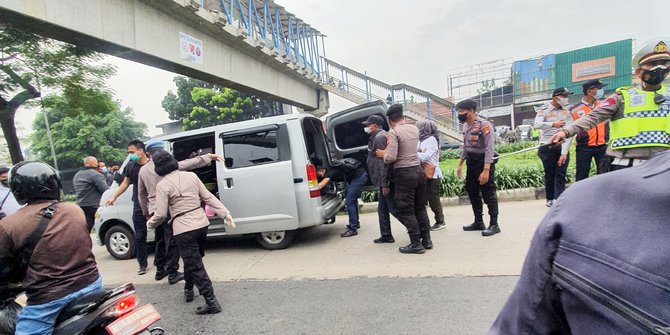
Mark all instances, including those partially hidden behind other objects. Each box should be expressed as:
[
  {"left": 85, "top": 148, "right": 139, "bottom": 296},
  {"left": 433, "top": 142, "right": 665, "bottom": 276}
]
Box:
[{"left": 363, "top": 115, "right": 395, "bottom": 243}]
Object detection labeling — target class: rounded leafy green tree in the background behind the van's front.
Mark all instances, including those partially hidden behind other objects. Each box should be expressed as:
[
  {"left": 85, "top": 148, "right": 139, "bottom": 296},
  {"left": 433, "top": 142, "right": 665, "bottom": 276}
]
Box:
[{"left": 30, "top": 90, "right": 147, "bottom": 169}]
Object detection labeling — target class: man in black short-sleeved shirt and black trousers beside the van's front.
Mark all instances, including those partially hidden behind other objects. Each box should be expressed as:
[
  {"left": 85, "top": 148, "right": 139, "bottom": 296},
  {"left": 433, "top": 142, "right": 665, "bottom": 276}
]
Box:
[{"left": 105, "top": 140, "right": 149, "bottom": 275}]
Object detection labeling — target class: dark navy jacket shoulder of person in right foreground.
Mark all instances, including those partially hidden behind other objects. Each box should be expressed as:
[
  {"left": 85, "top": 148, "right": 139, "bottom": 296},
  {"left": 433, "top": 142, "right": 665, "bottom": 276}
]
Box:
[{"left": 488, "top": 151, "right": 670, "bottom": 335}]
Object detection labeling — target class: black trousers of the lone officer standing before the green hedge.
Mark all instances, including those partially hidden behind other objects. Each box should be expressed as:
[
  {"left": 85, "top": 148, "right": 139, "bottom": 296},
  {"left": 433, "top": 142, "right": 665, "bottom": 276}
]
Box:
[{"left": 465, "top": 154, "right": 498, "bottom": 224}]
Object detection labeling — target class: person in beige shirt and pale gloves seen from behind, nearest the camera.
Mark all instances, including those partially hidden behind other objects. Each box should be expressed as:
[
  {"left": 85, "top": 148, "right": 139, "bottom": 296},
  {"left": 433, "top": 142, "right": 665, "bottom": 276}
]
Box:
[{"left": 147, "top": 150, "right": 235, "bottom": 314}]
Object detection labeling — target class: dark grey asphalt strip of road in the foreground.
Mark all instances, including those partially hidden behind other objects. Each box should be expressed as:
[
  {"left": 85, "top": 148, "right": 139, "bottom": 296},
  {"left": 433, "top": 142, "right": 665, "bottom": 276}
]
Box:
[{"left": 139, "top": 277, "right": 517, "bottom": 335}]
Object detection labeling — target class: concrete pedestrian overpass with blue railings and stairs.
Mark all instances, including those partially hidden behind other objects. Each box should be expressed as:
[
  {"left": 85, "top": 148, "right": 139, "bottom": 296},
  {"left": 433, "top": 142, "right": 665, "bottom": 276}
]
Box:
[{"left": 0, "top": 0, "right": 461, "bottom": 141}]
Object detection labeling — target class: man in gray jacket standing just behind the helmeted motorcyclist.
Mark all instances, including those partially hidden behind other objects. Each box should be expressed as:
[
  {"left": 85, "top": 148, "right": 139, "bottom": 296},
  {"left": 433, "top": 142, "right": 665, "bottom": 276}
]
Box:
[{"left": 72, "top": 156, "right": 109, "bottom": 232}]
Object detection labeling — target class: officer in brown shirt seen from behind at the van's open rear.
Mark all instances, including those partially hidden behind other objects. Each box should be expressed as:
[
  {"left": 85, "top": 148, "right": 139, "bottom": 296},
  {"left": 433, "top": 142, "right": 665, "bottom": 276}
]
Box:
[{"left": 377, "top": 104, "right": 433, "bottom": 254}]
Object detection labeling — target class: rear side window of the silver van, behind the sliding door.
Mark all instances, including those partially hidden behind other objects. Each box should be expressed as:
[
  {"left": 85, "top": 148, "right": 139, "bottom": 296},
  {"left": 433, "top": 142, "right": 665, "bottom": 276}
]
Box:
[{"left": 223, "top": 129, "right": 280, "bottom": 169}]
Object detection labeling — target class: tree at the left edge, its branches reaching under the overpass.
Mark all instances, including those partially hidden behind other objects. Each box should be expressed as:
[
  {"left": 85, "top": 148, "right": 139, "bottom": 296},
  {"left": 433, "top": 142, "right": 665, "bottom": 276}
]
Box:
[{"left": 0, "top": 26, "right": 115, "bottom": 163}]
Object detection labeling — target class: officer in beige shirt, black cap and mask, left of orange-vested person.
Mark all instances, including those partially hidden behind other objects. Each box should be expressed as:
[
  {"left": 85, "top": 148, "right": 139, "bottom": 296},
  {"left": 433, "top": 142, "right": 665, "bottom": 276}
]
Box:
[{"left": 533, "top": 87, "right": 572, "bottom": 207}]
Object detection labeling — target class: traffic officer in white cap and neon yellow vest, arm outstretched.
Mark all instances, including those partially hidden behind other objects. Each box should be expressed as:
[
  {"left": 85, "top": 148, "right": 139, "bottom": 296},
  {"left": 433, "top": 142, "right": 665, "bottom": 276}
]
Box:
[{"left": 551, "top": 38, "right": 670, "bottom": 170}]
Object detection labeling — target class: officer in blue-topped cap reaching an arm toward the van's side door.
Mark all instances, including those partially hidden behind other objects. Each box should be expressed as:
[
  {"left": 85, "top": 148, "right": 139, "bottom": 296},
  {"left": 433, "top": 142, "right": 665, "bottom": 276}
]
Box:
[{"left": 138, "top": 140, "right": 221, "bottom": 285}]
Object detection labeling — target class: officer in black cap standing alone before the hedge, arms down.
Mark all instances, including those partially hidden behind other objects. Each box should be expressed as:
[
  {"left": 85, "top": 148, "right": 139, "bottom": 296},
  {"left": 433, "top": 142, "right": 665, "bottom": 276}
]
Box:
[{"left": 456, "top": 99, "right": 500, "bottom": 236}]
